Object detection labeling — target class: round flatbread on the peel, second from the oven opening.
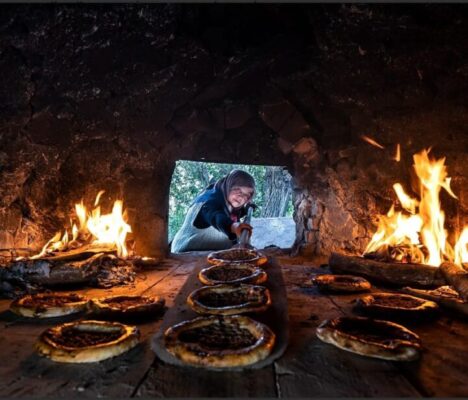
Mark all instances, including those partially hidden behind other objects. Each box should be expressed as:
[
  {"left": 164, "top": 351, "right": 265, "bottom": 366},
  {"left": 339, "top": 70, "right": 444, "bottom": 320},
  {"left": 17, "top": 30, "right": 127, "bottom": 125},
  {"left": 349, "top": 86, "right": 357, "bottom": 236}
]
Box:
[{"left": 198, "top": 263, "right": 268, "bottom": 285}]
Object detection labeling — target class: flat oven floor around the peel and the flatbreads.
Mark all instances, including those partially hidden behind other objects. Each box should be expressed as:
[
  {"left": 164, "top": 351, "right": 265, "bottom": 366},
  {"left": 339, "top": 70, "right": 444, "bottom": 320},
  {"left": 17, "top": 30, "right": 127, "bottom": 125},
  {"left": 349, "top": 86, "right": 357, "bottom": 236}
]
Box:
[{"left": 0, "top": 253, "right": 468, "bottom": 398}]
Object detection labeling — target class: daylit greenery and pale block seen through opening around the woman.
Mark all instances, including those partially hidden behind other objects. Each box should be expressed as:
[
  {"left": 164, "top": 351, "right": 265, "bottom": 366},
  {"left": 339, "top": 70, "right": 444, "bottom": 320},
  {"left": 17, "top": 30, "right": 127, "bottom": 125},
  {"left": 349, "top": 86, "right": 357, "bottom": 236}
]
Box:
[{"left": 168, "top": 160, "right": 295, "bottom": 252}]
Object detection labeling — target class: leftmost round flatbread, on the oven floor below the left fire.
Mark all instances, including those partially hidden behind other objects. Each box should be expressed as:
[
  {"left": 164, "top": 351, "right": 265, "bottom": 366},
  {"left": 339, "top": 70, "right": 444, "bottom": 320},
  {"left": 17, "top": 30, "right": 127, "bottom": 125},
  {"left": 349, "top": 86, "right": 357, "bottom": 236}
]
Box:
[{"left": 10, "top": 293, "right": 88, "bottom": 318}]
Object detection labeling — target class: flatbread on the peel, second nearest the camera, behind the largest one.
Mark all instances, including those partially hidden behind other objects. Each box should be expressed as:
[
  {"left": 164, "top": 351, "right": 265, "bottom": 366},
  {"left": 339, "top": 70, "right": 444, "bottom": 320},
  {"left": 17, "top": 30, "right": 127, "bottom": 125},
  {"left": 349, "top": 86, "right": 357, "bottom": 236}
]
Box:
[{"left": 187, "top": 284, "right": 271, "bottom": 315}]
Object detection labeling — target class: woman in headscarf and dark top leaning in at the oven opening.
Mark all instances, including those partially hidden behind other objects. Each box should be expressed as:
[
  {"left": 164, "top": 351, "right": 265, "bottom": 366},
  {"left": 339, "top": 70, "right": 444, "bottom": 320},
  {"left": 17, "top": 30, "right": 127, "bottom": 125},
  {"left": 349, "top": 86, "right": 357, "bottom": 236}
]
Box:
[{"left": 171, "top": 169, "right": 255, "bottom": 253}]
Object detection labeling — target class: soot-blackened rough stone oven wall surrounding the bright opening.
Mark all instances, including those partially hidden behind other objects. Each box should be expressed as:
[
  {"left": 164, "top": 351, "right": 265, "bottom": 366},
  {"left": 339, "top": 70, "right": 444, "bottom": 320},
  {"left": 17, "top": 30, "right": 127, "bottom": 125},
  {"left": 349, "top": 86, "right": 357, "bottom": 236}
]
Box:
[{"left": 0, "top": 4, "right": 468, "bottom": 255}]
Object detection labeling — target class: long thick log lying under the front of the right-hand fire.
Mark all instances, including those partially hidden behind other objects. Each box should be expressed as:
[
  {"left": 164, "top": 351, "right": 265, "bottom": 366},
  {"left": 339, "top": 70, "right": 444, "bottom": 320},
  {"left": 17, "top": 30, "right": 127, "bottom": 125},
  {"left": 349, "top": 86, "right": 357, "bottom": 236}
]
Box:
[{"left": 328, "top": 253, "right": 445, "bottom": 287}]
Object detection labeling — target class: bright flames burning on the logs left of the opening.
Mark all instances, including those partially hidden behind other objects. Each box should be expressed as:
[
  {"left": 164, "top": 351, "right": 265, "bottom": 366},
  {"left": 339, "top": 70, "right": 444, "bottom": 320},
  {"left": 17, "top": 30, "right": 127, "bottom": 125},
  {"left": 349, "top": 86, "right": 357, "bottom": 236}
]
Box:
[{"left": 31, "top": 190, "right": 132, "bottom": 259}]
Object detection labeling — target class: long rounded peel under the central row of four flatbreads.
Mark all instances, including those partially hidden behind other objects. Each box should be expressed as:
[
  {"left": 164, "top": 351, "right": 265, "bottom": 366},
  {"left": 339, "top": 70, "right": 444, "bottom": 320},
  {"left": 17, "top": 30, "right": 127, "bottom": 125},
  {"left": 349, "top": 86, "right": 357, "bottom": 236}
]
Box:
[{"left": 152, "top": 260, "right": 289, "bottom": 371}]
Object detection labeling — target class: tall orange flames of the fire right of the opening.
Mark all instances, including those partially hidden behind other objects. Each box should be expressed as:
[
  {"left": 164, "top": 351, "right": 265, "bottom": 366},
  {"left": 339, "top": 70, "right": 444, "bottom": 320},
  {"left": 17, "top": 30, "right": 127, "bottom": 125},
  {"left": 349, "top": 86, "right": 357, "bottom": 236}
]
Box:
[{"left": 365, "top": 150, "right": 468, "bottom": 266}]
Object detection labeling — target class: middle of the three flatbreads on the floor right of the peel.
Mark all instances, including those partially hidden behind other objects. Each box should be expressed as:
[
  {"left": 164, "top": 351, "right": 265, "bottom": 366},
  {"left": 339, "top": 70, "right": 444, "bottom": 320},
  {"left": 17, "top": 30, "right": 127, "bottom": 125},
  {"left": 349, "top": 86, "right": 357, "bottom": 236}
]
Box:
[{"left": 354, "top": 293, "right": 439, "bottom": 321}]
